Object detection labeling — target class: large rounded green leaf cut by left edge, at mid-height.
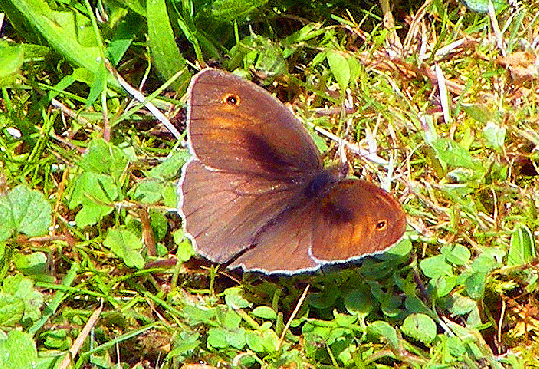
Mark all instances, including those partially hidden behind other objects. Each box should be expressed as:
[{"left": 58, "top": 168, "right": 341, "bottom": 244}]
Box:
[{"left": 0, "top": 185, "right": 52, "bottom": 241}]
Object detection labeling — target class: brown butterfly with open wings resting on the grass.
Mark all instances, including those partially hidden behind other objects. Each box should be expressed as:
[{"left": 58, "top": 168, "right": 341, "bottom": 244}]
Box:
[{"left": 178, "top": 69, "right": 406, "bottom": 274}]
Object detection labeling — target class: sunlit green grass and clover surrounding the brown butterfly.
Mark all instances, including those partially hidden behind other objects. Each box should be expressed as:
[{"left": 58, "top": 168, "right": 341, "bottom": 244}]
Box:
[{"left": 0, "top": 0, "right": 539, "bottom": 368}]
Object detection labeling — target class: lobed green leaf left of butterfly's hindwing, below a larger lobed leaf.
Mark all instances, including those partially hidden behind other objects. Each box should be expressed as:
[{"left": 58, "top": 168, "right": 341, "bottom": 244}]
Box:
[{"left": 103, "top": 228, "right": 144, "bottom": 269}]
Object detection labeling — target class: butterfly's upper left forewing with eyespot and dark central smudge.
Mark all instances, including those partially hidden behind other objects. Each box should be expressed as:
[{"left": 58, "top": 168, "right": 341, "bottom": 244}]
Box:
[{"left": 188, "top": 69, "right": 322, "bottom": 181}]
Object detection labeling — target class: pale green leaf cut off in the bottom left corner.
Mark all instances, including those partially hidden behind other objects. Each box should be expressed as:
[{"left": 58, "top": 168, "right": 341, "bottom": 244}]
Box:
[{"left": 0, "top": 330, "right": 38, "bottom": 369}]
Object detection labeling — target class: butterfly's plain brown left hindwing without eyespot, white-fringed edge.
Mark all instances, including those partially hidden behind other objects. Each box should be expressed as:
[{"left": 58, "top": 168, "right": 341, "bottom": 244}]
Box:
[{"left": 179, "top": 159, "right": 310, "bottom": 263}]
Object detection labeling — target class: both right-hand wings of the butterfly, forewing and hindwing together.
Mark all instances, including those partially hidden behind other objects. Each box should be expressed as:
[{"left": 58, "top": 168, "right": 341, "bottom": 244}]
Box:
[{"left": 230, "top": 177, "right": 406, "bottom": 274}]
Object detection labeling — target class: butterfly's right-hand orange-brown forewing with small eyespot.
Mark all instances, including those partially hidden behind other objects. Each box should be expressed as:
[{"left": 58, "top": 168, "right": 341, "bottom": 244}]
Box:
[{"left": 310, "top": 179, "right": 406, "bottom": 263}]
